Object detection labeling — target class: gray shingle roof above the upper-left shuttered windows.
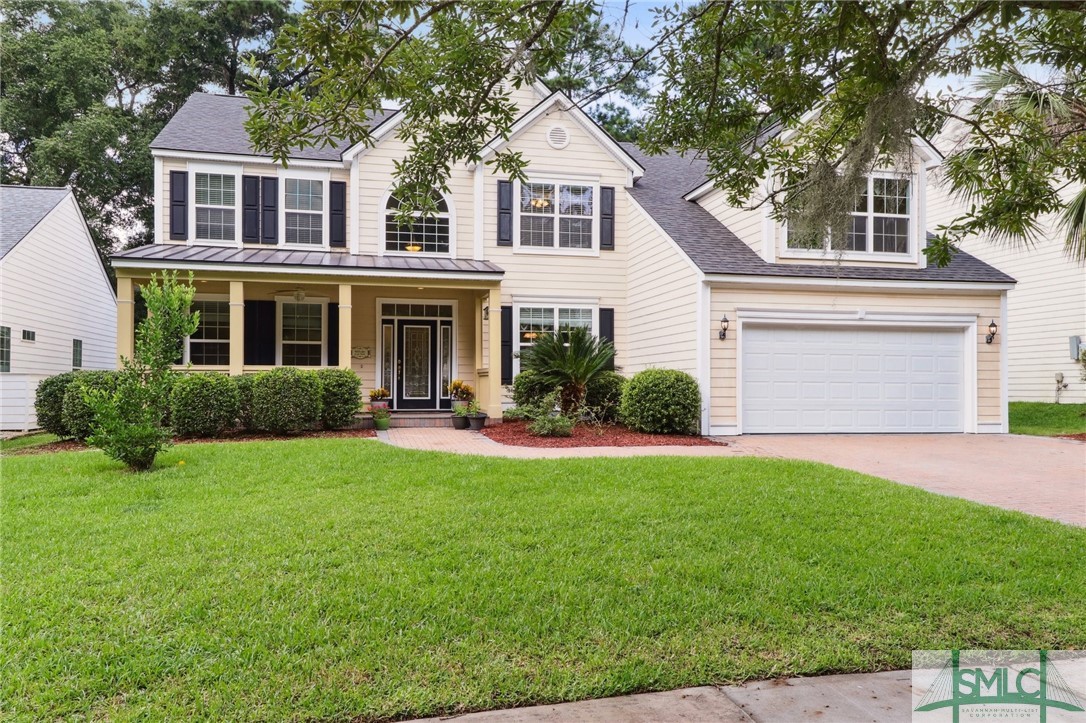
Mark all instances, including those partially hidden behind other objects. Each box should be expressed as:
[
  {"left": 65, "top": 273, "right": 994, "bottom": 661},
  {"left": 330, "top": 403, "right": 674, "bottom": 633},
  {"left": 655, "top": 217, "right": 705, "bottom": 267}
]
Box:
[{"left": 151, "top": 93, "right": 395, "bottom": 161}]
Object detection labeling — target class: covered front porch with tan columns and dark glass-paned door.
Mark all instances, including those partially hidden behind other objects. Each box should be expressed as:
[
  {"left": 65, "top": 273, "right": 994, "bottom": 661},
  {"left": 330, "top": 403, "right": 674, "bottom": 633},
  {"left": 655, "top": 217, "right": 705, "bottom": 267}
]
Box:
[{"left": 117, "top": 252, "right": 502, "bottom": 416}]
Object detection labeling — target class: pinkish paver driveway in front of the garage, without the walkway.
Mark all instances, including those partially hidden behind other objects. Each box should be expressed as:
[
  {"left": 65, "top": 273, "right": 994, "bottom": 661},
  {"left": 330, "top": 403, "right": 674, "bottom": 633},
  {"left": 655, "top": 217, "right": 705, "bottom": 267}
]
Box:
[{"left": 727, "top": 434, "right": 1086, "bottom": 525}]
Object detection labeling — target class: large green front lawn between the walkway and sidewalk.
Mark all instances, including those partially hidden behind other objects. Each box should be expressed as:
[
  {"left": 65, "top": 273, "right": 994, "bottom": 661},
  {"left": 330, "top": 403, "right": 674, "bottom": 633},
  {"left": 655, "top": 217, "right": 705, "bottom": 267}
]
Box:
[{"left": 0, "top": 440, "right": 1086, "bottom": 721}]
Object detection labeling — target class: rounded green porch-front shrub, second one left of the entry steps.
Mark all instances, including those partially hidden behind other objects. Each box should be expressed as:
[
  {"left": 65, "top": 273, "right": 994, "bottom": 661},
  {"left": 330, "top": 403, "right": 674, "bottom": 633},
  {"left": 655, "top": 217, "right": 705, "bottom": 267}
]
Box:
[{"left": 253, "top": 367, "right": 320, "bottom": 434}]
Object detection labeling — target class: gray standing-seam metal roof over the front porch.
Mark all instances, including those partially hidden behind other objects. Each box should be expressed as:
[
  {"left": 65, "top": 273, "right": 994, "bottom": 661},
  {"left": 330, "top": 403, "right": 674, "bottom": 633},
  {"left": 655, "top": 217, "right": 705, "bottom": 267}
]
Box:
[{"left": 113, "top": 243, "right": 505, "bottom": 276}]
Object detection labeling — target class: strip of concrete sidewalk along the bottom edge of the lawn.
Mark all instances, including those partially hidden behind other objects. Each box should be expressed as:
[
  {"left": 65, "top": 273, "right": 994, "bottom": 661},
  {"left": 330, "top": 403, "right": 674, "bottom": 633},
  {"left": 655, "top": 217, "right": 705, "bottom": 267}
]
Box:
[{"left": 410, "top": 670, "right": 912, "bottom": 723}]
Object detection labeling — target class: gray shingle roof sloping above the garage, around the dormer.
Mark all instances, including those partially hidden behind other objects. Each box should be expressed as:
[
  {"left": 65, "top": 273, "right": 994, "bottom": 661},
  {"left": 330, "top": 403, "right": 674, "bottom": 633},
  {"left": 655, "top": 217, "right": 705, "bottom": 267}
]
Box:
[{"left": 622, "top": 143, "right": 1014, "bottom": 283}]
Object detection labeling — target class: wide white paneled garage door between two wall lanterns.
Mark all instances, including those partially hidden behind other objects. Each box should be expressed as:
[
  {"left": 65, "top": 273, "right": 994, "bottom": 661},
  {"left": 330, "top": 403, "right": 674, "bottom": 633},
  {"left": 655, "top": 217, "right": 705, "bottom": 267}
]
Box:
[{"left": 740, "top": 326, "right": 965, "bottom": 433}]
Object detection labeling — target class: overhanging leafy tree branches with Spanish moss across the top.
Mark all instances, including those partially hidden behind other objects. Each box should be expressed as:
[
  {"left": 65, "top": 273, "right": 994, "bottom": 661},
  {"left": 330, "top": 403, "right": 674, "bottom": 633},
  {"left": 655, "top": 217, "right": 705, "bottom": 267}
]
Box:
[{"left": 249, "top": 0, "right": 1086, "bottom": 264}]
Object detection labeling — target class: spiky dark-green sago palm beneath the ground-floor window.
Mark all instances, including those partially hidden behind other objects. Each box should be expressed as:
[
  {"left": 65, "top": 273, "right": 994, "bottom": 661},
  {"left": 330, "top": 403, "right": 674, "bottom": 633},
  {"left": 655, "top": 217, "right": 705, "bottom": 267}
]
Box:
[{"left": 520, "top": 327, "right": 615, "bottom": 410}]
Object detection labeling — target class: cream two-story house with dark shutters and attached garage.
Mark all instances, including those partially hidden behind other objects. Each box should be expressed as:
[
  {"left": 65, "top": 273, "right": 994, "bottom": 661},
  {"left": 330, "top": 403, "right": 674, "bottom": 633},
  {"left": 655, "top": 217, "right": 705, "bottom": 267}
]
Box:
[{"left": 114, "top": 85, "right": 1013, "bottom": 434}]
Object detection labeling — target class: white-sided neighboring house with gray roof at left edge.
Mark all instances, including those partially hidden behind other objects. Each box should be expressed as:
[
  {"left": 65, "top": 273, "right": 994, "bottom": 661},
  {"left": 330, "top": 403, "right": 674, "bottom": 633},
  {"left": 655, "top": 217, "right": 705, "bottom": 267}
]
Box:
[{"left": 0, "top": 186, "right": 117, "bottom": 431}]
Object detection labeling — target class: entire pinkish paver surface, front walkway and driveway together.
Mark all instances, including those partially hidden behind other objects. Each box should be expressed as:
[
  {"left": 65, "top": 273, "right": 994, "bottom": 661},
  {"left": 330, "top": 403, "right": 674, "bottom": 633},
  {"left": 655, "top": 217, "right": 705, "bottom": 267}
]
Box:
[{"left": 378, "top": 429, "right": 1086, "bottom": 527}]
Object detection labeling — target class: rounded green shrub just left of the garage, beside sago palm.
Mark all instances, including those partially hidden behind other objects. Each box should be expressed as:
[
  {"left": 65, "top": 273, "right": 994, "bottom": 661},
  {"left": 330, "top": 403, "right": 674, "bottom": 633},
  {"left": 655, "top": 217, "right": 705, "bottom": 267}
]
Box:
[{"left": 621, "top": 369, "right": 702, "bottom": 434}]
